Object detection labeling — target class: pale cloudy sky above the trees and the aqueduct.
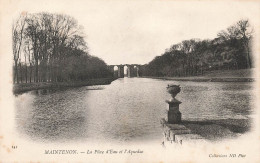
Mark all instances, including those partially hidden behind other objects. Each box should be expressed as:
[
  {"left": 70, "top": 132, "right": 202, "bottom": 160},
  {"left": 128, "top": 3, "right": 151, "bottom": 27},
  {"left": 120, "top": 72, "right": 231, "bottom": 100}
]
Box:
[{"left": 6, "top": 0, "right": 260, "bottom": 65}]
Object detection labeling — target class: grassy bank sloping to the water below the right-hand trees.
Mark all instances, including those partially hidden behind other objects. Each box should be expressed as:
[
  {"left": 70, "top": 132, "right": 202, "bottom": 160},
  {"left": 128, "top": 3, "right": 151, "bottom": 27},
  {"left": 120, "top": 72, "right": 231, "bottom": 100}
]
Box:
[{"left": 143, "top": 69, "right": 255, "bottom": 82}]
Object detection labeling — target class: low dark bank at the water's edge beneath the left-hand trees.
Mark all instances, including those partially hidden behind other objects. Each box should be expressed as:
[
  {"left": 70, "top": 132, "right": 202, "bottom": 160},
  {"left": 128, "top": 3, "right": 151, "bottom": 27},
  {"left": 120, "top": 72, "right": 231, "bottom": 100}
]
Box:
[{"left": 13, "top": 78, "right": 115, "bottom": 94}]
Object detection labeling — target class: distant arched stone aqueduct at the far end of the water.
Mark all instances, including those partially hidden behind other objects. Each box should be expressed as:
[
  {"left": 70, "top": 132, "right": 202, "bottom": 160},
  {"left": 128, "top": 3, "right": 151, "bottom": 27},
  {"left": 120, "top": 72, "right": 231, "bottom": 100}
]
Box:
[{"left": 108, "top": 64, "right": 141, "bottom": 78}]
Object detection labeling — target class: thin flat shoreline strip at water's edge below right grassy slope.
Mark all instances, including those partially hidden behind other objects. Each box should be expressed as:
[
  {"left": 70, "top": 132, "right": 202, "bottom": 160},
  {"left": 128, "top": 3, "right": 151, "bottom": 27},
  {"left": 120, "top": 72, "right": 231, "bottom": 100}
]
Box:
[{"left": 141, "top": 76, "right": 255, "bottom": 82}]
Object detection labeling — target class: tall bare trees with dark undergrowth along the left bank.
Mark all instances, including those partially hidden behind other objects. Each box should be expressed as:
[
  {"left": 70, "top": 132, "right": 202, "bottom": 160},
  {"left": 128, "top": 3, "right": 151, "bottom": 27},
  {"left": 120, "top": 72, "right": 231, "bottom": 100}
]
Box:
[{"left": 12, "top": 13, "right": 112, "bottom": 83}]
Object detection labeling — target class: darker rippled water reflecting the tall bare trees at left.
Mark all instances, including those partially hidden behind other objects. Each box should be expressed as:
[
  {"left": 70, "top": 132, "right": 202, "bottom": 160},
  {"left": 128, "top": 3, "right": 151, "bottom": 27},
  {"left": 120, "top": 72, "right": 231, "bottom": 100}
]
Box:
[{"left": 16, "top": 88, "right": 88, "bottom": 140}]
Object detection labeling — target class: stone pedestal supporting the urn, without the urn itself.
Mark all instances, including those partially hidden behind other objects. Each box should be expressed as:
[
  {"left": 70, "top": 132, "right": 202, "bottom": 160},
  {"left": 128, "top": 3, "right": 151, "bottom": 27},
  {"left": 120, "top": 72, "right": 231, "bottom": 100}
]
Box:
[{"left": 166, "top": 98, "right": 181, "bottom": 124}]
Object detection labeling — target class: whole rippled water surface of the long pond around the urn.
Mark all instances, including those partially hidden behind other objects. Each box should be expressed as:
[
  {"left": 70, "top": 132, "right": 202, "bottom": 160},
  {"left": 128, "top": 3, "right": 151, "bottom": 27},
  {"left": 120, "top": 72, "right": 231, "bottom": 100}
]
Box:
[{"left": 15, "top": 78, "right": 253, "bottom": 143}]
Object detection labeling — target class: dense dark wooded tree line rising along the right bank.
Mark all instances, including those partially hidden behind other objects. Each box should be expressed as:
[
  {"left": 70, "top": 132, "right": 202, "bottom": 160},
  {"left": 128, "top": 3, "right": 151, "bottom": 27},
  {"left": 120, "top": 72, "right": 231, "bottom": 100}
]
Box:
[{"left": 140, "top": 20, "right": 253, "bottom": 76}]
